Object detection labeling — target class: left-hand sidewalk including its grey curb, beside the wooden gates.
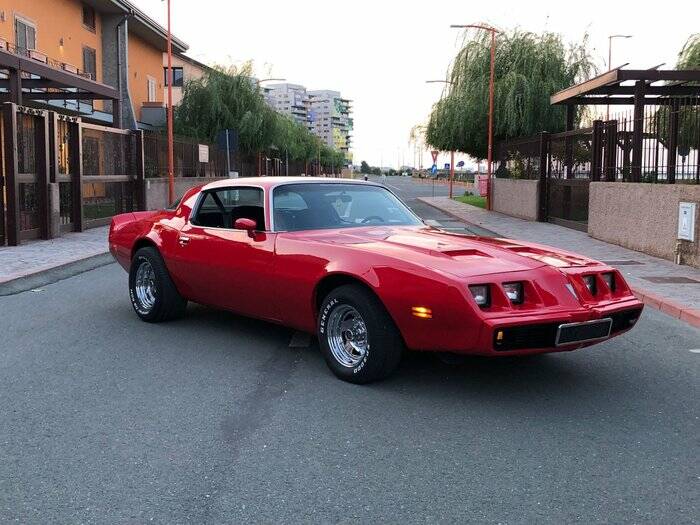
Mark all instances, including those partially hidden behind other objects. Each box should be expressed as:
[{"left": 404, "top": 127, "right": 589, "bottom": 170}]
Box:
[{"left": 0, "top": 226, "right": 112, "bottom": 295}]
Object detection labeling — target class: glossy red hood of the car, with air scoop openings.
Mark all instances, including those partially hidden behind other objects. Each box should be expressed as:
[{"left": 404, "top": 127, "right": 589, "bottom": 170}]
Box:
[{"left": 295, "top": 227, "right": 600, "bottom": 277}]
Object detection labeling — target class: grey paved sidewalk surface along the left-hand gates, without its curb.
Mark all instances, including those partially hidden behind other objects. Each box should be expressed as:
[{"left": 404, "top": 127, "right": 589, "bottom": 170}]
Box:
[{"left": 0, "top": 226, "right": 109, "bottom": 284}]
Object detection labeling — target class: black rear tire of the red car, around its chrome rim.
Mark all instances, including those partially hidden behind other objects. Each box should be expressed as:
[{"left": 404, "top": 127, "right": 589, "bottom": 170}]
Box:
[{"left": 129, "top": 247, "right": 187, "bottom": 323}]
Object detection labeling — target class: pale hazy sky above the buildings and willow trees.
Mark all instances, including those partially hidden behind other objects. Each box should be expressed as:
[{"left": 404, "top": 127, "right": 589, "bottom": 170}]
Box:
[{"left": 132, "top": 0, "right": 700, "bottom": 167}]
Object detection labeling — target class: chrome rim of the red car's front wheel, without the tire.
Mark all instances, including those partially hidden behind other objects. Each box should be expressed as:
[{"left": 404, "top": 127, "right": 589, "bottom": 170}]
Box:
[{"left": 327, "top": 304, "right": 369, "bottom": 368}]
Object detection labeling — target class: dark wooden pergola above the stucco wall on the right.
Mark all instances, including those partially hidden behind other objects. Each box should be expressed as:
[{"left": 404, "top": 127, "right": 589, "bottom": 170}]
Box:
[{"left": 550, "top": 68, "right": 700, "bottom": 182}]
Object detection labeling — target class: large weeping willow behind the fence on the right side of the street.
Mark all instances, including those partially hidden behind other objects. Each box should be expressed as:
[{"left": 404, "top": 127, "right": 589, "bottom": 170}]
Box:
[{"left": 426, "top": 30, "right": 595, "bottom": 159}]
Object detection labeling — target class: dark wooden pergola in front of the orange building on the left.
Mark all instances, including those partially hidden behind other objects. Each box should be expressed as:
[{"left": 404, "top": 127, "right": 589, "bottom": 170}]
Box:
[{"left": 0, "top": 44, "right": 121, "bottom": 127}]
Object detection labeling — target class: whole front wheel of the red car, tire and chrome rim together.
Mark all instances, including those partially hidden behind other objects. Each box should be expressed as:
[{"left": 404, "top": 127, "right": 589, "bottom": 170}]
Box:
[{"left": 318, "top": 285, "right": 403, "bottom": 383}]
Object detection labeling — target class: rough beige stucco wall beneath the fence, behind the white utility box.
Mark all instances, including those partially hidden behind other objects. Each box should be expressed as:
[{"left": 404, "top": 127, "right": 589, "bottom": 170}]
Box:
[{"left": 588, "top": 182, "right": 700, "bottom": 267}]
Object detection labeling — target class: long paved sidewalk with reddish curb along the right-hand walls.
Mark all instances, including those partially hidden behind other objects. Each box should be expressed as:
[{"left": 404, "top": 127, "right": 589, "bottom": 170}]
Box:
[{"left": 418, "top": 197, "right": 700, "bottom": 327}]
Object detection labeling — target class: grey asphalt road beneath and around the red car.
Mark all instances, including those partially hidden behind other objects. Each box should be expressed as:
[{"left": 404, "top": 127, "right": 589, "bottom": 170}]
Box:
[{"left": 0, "top": 180, "right": 700, "bottom": 524}]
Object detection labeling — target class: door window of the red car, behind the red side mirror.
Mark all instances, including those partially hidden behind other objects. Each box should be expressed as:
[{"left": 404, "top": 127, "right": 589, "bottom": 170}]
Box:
[{"left": 191, "top": 187, "right": 265, "bottom": 230}]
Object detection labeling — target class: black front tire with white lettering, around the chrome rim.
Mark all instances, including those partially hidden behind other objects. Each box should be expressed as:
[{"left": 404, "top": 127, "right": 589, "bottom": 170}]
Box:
[{"left": 317, "top": 285, "right": 404, "bottom": 384}]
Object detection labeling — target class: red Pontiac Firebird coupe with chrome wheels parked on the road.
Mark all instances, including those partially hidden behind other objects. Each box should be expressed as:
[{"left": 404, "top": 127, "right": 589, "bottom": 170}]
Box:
[{"left": 109, "top": 177, "right": 642, "bottom": 383}]
